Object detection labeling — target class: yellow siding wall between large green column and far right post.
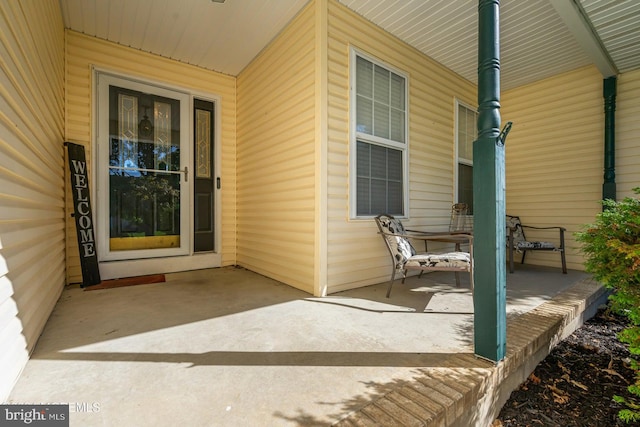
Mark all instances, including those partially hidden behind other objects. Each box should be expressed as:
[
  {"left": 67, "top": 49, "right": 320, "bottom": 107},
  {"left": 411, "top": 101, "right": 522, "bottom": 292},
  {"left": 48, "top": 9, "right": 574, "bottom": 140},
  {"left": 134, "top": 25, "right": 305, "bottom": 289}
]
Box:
[{"left": 501, "top": 67, "right": 604, "bottom": 270}]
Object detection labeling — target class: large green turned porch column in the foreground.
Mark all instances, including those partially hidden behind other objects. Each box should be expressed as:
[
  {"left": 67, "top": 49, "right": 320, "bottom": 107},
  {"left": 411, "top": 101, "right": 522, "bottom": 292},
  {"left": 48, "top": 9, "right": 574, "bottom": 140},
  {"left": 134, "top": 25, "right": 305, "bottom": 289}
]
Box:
[{"left": 473, "top": 0, "right": 507, "bottom": 362}]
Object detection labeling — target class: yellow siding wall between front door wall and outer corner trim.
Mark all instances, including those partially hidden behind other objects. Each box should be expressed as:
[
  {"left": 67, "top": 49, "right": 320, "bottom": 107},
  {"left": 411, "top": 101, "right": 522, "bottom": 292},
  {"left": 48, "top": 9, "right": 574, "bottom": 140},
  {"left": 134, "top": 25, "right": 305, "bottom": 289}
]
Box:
[{"left": 237, "top": 1, "right": 317, "bottom": 293}]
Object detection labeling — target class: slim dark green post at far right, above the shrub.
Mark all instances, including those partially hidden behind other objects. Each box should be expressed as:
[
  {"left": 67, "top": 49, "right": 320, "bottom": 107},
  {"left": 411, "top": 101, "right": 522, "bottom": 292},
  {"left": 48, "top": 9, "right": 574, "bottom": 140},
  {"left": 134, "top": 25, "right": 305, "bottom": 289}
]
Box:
[{"left": 602, "top": 76, "right": 616, "bottom": 200}]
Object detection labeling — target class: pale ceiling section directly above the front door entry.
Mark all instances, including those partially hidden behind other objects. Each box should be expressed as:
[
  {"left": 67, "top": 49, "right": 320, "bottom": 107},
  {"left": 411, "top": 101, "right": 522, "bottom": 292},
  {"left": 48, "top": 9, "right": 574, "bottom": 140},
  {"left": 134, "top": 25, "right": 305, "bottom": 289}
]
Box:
[{"left": 60, "top": 0, "right": 308, "bottom": 76}]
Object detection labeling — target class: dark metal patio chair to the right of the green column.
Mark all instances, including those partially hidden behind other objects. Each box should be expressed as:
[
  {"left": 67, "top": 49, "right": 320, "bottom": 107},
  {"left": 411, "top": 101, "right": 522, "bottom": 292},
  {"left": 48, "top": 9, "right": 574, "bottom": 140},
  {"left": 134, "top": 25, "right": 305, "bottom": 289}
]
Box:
[{"left": 507, "top": 215, "right": 567, "bottom": 274}]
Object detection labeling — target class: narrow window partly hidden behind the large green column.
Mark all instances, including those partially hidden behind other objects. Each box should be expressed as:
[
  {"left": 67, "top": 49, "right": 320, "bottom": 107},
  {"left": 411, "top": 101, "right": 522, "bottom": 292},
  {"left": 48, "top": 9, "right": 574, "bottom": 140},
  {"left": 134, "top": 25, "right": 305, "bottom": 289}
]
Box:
[{"left": 456, "top": 102, "right": 478, "bottom": 215}]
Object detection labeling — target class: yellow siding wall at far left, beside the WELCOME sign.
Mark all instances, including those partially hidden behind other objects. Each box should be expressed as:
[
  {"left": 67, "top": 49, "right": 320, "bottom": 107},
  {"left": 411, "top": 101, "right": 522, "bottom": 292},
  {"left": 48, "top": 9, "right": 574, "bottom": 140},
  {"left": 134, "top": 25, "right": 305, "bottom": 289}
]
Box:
[{"left": 0, "top": 1, "right": 65, "bottom": 401}]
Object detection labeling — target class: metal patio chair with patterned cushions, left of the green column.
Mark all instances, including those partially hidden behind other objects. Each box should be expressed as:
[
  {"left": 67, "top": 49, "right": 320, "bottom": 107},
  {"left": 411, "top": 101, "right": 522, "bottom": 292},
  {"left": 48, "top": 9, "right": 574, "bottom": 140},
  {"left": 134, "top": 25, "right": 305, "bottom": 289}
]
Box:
[{"left": 375, "top": 214, "right": 473, "bottom": 298}]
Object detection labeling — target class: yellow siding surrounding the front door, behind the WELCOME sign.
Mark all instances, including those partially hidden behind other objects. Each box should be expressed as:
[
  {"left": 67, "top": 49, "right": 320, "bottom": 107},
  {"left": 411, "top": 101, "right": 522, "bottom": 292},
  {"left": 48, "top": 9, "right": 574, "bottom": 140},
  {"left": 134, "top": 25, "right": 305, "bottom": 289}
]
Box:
[{"left": 65, "top": 31, "right": 236, "bottom": 283}]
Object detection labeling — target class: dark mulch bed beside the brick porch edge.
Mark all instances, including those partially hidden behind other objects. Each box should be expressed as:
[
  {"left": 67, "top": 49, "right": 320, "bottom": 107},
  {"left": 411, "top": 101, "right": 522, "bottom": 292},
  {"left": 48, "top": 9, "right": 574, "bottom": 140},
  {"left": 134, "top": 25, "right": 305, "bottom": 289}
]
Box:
[{"left": 493, "top": 310, "right": 634, "bottom": 427}]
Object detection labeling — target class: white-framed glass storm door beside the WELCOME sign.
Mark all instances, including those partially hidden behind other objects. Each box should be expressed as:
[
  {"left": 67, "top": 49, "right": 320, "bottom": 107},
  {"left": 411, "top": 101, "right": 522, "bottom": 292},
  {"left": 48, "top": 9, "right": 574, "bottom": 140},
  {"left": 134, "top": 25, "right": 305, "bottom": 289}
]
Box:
[{"left": 98, "top": 75, "right": 190, "bottom": 260}]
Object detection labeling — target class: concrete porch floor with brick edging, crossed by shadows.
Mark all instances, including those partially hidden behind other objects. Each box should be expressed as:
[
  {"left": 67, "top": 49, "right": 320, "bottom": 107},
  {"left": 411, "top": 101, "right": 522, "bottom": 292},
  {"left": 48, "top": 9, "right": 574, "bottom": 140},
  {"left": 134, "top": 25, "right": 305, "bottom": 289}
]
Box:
[{"left": 8, "top": 266, "right": 606, "bottom": 426}]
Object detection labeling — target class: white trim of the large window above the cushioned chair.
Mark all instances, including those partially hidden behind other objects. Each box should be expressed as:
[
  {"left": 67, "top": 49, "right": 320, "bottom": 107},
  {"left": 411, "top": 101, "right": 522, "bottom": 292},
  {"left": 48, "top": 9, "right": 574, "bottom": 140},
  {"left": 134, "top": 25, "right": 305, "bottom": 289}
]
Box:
[{"left": 349, "top": 46, "right": 410, "bottom": 220}]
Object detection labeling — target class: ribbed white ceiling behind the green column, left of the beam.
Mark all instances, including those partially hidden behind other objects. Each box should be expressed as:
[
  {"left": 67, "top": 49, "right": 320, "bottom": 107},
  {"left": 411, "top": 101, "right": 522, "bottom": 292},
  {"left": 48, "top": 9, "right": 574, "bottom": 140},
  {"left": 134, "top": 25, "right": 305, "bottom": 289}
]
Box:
[{"left": 339, "top": 0, "right": 591, "bottom": 90}]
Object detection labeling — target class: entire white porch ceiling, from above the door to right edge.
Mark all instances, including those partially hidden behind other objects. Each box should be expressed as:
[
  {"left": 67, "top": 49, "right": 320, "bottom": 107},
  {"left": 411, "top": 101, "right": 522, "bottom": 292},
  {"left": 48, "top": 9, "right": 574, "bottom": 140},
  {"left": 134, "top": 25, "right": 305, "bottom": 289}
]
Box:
[{"left": 60, "top": 0, "right": 640, "bottom": 90}]
